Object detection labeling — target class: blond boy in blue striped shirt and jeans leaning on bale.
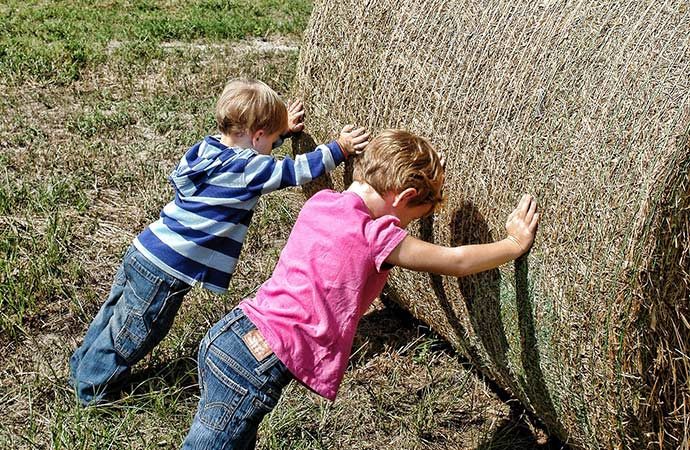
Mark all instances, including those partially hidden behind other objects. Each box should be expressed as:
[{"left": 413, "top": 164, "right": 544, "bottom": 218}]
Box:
[{"left": 70, "top": 80, "right": 369, "bottom": 405}]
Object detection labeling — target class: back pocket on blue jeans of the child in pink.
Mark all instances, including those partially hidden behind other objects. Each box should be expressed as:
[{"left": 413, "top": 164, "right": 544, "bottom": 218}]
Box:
[{"left": 199, "top": 358, "right": 248, "bottom": 431}]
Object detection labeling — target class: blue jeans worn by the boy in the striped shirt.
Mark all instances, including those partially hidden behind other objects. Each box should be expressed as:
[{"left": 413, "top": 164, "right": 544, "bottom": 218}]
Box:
[{"left": 70, "top": 245, "right": 191, "bottom": 405}]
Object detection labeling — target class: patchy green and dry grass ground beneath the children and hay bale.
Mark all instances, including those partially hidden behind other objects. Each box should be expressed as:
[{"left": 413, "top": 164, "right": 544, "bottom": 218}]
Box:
[{"left": 0, "top": 1, "right": 538, "bottom": 449}]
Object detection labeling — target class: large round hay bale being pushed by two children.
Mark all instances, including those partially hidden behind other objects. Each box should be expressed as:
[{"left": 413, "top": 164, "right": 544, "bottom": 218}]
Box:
[{"left": 288, "top": 0, "right": 690, "bottom": 448}]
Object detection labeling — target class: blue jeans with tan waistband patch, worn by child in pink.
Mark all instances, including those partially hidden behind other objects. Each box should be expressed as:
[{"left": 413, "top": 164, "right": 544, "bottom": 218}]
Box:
[{"left": 182, "top": 308, "right": 292, "bottom": 450}]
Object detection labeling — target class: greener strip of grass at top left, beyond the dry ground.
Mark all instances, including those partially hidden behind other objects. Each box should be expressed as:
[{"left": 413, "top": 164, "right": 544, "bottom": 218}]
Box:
[{"left": 0, "top": 0, "right": 311, "bottom": 83}]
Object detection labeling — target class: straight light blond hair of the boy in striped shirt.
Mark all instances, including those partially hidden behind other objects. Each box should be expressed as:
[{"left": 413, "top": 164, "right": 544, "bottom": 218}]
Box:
[{"left": 216, "top": 79, "right": 288, "bottom": 135}]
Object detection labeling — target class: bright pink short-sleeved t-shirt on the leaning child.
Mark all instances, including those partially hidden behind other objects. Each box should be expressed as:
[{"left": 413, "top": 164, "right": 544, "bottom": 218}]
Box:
[{"left": 240, "top": 190, "right": 407, "bottom": 400}]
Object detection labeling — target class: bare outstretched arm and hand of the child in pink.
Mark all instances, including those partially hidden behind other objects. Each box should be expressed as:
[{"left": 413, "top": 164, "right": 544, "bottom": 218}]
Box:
[{"left": 386, "top": 194, "right": 539, "bottom": 277}]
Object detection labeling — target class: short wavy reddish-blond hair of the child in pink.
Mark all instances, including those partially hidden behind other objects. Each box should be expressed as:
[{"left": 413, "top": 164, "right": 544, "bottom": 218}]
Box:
[{"left": 353, "top": 130, "right": 444, "bottom": 206}]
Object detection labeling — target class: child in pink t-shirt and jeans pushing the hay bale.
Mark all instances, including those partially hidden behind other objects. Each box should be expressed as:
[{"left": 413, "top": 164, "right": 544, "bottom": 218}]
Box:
[{"left": 183, "top": 130, "right": 539, "bottom": 449}]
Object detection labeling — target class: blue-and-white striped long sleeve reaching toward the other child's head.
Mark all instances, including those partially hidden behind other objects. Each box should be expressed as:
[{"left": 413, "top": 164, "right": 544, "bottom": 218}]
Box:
[{"left": 245, "top": 141, "right": 345, "bottom": 194}]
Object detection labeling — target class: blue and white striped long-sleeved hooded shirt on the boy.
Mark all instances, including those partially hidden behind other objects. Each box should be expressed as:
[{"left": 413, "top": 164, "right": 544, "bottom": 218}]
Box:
[{"left": 134, "top": 136, "right": 345, "bottom": 293}]
